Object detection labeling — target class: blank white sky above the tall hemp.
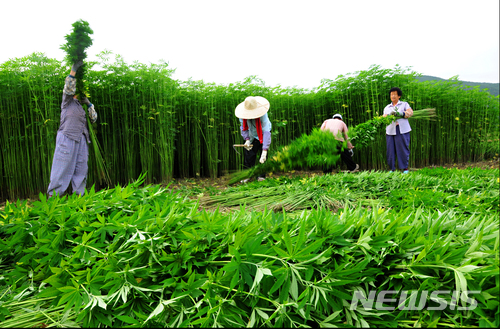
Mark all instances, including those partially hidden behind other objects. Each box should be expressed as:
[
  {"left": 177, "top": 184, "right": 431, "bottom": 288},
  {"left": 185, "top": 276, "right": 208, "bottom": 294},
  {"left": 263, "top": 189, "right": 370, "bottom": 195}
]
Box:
[{"left": 0, "top": 0, "right": 500, "bottom": 88}]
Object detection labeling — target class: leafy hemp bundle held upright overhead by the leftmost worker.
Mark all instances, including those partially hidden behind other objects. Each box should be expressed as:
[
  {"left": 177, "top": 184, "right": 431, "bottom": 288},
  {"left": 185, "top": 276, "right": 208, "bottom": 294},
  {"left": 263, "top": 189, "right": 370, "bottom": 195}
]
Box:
[{"left": 60, "top": 20, "right": 94, "bottom": 96}]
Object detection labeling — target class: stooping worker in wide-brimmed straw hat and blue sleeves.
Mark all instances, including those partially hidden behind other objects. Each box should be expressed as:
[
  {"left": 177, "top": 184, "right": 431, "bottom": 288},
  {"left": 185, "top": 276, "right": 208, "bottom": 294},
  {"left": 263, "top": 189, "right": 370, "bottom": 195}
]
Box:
[{"left": 234, "top": 96, "right": 272, "bottom": 183}]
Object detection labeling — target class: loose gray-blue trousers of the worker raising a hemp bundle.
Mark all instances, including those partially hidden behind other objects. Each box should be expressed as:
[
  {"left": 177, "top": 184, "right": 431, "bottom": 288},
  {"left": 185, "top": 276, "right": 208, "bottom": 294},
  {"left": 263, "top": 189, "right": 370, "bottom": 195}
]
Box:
[{"left": 47, "top": 132, "right": 89, "bottom": 197}]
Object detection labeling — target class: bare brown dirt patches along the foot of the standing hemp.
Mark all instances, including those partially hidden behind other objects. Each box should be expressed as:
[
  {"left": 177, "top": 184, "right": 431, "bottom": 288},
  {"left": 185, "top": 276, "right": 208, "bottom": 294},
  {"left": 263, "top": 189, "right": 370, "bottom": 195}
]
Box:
[{"left": 0, "top": 157, "right": 500, "bottom": 211}]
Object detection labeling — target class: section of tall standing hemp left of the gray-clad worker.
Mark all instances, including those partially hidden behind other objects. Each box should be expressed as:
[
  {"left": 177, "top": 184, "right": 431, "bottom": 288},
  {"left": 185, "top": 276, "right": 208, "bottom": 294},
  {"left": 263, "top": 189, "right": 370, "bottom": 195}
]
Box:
[{"left": 0, "top": 53, "right": 65, "bottom": 200}]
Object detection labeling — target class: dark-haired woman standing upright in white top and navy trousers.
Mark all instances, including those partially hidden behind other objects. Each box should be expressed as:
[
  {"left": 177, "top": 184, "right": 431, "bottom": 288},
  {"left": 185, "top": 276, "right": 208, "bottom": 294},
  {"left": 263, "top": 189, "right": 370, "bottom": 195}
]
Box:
[{"left": 384, "top": 87, "right": 413, "bottom": 174}]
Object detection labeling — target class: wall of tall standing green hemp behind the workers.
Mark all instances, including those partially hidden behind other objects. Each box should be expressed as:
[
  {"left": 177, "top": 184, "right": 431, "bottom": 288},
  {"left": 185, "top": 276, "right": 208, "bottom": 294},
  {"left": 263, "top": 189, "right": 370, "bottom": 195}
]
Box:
[{"left": 0, "top": 52, "right": 499, "bottom": 200}]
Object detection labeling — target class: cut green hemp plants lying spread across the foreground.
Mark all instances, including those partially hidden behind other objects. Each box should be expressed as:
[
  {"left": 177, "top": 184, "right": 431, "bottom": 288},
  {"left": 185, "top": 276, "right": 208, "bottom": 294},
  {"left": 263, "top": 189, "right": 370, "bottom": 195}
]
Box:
[{"left": 0, "top": 168, "right": 500, "bottom": 328}]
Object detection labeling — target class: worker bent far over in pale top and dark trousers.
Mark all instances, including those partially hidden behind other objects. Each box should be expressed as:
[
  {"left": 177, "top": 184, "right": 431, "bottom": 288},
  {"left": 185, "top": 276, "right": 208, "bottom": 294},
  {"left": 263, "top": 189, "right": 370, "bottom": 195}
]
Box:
[{"left": 320, "top": 113, "right": 359, "bottom": 174}]
